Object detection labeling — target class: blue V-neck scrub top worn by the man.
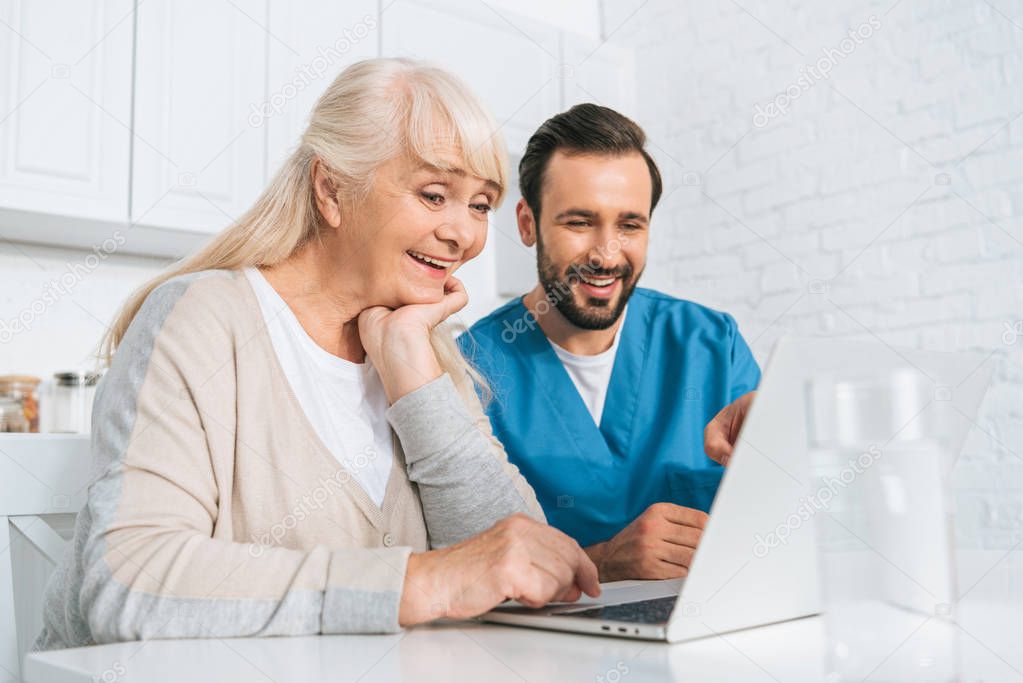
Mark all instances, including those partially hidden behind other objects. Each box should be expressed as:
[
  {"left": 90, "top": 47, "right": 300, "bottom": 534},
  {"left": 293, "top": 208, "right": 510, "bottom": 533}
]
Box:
[{"left": 458, "top": 287, "right": 760, "bottom": 546}]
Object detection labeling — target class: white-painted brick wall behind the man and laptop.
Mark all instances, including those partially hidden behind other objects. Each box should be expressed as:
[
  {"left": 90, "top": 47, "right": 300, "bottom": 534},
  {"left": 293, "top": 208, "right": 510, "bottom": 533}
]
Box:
[{"left": 604, "top": 0, "right": 1023, "bottom": 563}]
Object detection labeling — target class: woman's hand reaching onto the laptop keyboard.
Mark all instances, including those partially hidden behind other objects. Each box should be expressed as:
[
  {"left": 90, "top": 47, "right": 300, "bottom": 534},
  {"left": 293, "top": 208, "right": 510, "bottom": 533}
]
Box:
[{"left": 398, "top": 514, "right": 601, "bottom": 627}]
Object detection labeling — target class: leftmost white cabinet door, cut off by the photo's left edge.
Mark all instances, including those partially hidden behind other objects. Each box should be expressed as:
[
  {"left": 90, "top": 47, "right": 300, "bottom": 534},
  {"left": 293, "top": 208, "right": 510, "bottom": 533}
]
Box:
[{"left": 0, "top": 0, "right": 133, "bottom": 223}]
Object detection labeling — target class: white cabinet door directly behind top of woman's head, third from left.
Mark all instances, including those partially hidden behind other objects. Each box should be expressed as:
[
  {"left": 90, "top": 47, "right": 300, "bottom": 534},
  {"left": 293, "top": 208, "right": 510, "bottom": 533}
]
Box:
[{"left": 263, "top": 0, "right": 380, "bottom": 178}]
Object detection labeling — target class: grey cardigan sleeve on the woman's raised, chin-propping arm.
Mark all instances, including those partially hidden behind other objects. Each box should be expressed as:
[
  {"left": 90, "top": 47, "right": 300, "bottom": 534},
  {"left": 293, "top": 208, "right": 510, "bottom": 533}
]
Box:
[{"left": 388, "top": 361, "right": 546, "bottom": 548}]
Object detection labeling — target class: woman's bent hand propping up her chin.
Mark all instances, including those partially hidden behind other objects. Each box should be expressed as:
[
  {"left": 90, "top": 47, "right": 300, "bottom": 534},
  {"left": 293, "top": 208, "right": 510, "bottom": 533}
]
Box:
[{"left": 359, "top": 277, "right": 469, "bottom": 404}]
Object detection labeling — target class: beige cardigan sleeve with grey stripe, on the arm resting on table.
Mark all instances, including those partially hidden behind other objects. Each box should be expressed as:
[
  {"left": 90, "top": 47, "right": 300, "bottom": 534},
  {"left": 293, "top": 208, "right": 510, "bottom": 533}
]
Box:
[{"left": 36, "top": 280, "right": 410, "bottom": 649}]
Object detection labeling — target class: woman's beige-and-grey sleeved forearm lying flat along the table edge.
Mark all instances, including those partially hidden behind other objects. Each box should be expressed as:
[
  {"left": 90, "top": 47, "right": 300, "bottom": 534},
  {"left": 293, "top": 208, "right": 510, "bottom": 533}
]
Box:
[{"left": 72, "top": 519, "right": 410, "bottom": 643}]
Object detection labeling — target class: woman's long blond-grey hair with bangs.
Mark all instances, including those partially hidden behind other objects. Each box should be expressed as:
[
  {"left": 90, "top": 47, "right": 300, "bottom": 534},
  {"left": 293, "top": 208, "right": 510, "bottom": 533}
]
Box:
[{"left": 101, "top": 58, "right": 507, "bottom": 390}]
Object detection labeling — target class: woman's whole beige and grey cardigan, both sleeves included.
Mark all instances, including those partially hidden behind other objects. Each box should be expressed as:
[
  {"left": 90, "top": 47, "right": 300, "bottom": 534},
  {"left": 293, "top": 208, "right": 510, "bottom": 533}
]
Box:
[{"left": 36, "top": 271, "right": 543, "bottom": 649}]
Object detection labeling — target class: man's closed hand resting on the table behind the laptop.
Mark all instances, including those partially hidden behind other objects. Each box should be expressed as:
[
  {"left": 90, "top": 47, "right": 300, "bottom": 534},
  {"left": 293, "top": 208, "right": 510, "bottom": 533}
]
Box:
[{"left": 585, "top": 503, "right": 707, "bottom": 581}]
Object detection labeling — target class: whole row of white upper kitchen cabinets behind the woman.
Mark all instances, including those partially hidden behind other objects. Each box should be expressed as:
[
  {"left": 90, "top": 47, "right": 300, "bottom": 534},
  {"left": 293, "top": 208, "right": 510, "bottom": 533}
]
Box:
[{"left": 0, "top": 0, "right": 634, "bottom": 269}]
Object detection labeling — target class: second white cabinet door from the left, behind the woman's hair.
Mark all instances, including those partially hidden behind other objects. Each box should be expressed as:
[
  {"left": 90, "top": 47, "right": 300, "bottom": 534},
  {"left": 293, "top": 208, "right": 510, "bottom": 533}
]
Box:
[{"left": 131, "top": 0, "right": 274, "bottom": 232}]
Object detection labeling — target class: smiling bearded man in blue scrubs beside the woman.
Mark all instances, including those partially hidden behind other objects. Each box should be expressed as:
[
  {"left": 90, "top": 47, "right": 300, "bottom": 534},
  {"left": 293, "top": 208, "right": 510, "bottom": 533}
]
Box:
[{"left": 458, "top": 104, "right": 760, "bottom": 581}]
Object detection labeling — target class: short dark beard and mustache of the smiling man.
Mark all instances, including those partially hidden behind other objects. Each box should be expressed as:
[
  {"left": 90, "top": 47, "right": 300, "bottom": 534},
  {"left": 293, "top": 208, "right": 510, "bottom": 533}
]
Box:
[{"left": 536, "top": 239, "right": 639, "bottom": 329}]
